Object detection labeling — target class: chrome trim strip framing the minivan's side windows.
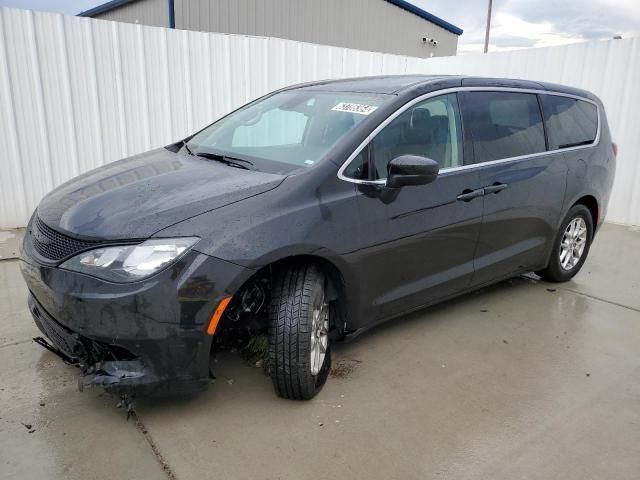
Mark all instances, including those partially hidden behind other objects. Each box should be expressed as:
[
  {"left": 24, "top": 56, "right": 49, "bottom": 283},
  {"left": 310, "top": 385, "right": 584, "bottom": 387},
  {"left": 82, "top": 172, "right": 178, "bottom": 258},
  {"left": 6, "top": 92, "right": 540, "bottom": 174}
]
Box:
[{"left": 338, "top": 87, "right": 602, "bottom": 185}]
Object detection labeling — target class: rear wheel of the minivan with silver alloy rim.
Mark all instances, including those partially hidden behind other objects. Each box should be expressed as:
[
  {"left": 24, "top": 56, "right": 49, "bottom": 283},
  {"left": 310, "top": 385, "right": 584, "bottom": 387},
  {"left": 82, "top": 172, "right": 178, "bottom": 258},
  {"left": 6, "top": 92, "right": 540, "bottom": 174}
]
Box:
[{"left": 536, "top": 204, "right": 593, "bottom": 282}]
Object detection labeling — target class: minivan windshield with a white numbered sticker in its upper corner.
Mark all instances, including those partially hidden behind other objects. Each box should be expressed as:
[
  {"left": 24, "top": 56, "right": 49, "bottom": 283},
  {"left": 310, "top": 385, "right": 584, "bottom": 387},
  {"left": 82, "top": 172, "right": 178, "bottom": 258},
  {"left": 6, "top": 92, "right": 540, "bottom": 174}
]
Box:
[{"left": 187, "top": 90, "right": 388, "bottom": 173}]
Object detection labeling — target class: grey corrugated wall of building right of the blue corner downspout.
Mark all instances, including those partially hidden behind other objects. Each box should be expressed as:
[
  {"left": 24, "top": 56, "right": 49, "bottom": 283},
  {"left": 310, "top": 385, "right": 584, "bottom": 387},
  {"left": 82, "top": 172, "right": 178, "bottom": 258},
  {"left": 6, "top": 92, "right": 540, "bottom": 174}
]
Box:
[{"left": 172, "top": 0, "right": 458, "bottom": 58}]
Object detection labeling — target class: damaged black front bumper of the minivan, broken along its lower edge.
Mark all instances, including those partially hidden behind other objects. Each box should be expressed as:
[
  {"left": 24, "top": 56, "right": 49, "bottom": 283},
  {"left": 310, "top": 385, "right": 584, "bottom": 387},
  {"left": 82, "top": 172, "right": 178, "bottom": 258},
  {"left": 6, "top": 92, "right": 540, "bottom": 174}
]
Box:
[{"left": 20, "top": 236, "right": 253, "bottom": 396}]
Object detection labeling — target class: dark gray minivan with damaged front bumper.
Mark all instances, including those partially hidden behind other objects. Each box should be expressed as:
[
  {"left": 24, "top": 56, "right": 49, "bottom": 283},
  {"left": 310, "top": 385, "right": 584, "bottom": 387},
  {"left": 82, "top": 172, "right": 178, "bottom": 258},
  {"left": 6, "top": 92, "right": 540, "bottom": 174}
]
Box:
[{"left": 21, "top": 76, "right": 617, "bottom": 399}]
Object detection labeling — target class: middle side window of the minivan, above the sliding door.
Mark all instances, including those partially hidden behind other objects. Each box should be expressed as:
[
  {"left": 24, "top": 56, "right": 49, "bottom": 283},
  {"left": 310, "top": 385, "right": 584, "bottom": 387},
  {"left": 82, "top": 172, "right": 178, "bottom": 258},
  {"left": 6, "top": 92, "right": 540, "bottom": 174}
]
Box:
[{"left": 462, "top": 92, "right": 546, "bottom": 163}]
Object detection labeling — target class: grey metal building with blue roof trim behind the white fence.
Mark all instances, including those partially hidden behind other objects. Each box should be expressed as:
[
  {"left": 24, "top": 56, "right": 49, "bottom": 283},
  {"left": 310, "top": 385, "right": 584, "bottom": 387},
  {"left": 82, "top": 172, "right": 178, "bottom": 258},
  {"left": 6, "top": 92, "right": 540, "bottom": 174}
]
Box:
[{"left": 79, "top": 0, "right": 462, "bottom": 58}]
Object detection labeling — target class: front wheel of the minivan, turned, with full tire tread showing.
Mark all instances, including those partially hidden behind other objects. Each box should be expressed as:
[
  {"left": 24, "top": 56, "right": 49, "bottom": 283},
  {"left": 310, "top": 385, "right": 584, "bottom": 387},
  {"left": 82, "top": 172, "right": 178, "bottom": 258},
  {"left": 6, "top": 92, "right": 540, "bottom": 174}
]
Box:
[{"left": 269, "top": 265, "right": 331, "bottom": 400}]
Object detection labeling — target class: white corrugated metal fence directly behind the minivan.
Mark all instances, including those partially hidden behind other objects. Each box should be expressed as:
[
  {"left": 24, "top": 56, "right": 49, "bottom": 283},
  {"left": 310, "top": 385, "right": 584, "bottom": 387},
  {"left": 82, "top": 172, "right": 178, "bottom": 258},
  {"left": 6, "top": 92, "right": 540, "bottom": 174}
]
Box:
[{"left": 0, "top": 8, "right": 640, "bottom": 228}]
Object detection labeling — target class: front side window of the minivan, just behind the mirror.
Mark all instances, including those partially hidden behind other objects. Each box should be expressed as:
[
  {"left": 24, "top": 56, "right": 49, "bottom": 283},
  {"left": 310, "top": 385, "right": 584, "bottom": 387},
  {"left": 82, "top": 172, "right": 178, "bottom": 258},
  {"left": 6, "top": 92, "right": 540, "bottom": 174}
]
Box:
[{"left": 370, "top": 93, "right": 463, "bottom": 180}]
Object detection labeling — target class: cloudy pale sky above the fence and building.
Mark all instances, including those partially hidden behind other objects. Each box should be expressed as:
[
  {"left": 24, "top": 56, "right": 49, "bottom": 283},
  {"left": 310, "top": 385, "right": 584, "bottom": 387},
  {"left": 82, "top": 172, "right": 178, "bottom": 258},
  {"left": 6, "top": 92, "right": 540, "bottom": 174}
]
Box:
[{"left": 0, "top": 0, "right": 640, "bottom": 53}]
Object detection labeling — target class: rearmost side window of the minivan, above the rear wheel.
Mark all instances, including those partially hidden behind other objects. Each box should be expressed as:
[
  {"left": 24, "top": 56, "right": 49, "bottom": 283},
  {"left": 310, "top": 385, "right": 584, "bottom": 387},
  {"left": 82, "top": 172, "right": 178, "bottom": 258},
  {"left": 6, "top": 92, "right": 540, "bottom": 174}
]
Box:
[{"left": 540, "top": 95, "right": 598, "bottom": 150}]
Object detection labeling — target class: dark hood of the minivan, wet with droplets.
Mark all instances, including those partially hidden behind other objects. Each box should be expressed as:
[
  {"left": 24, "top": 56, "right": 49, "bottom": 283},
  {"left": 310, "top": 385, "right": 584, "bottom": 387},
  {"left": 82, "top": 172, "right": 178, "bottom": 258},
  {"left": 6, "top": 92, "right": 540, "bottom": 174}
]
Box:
[{"left": 38, "top": 148, "right": 285, "bottom": 240}]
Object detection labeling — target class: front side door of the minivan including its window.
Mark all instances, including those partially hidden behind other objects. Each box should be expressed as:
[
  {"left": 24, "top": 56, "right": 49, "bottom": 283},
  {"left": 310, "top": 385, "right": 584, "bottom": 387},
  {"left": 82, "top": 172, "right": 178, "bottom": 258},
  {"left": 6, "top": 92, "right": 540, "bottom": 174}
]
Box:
[{"left": 348, "top": 94, "right": 483, "bottom": 321}]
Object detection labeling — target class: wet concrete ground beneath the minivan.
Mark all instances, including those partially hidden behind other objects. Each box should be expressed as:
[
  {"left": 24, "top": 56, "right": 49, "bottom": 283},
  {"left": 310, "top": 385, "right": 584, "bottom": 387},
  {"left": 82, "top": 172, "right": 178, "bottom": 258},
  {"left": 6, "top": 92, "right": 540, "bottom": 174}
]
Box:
[{"left": 0, "top": 225, "right": 640, "bottom": 480}]
